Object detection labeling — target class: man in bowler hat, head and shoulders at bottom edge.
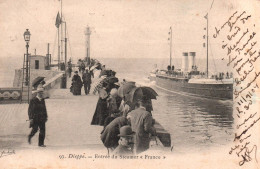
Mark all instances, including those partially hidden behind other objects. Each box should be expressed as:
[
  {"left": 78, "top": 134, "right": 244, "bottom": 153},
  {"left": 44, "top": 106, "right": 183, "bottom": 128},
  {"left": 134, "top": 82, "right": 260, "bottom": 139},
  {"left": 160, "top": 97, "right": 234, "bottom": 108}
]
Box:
[{"left": 113, "top": 125, "right": 135, "bottom": 155}]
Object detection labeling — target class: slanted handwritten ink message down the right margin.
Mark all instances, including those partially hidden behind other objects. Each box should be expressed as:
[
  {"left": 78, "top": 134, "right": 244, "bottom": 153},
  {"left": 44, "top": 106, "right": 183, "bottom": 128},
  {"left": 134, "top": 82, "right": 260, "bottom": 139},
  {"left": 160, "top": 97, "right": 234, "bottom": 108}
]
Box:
[{"left": 213, "top": 11, "right": 260, "bottom": 166}]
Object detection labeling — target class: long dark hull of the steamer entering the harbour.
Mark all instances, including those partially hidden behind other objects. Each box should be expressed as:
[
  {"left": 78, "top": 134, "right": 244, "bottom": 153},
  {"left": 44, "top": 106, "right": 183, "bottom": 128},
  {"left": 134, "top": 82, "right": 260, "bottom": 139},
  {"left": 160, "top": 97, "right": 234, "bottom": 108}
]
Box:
[{"left": 156, "top": 75, "right": 233, "bottom": 100}]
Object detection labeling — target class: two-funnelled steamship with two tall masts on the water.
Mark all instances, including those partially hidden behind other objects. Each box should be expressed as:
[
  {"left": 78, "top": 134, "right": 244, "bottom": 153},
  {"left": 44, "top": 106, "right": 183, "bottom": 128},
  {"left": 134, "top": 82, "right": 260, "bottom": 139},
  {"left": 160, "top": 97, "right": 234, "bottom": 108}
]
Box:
[{"left": 149, "top": 22, "right": 233, "bottom": 100}]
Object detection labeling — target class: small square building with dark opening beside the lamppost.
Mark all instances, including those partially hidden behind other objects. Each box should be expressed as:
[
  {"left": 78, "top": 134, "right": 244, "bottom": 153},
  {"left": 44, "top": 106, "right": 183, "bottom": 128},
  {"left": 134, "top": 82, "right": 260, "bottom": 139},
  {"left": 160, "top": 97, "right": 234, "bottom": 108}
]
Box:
[{"left": 30, "top": 55, "right": 49, "bottom": 70}]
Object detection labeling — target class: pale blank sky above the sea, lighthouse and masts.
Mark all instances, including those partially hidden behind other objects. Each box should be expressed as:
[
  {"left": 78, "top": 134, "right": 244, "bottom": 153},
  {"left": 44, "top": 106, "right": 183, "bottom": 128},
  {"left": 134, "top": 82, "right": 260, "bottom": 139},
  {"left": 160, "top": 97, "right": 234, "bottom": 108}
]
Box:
[{"left": 0, "top": 0, "right": 260, "bottom": 62}]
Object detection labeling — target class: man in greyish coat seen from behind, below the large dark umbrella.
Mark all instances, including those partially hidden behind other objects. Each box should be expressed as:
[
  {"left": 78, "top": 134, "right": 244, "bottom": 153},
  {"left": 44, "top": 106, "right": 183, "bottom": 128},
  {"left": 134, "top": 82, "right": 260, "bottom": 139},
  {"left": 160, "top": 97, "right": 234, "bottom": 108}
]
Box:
[{"left": 127, "top": 100, "right": 156, "bottom": 154}]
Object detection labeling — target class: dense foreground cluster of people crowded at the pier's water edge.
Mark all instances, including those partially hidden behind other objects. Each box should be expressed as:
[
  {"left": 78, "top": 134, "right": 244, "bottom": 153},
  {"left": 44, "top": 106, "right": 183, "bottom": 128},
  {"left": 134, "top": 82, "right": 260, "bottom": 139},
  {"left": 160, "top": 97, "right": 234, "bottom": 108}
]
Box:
[{"left": 88, "top": 65, "right": 156, "bottom": 155}]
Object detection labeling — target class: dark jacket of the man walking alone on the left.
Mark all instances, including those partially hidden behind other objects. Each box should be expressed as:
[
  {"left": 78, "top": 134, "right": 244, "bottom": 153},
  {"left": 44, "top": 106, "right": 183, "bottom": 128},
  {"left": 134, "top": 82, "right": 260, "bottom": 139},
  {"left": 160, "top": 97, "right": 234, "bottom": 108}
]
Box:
[{"left": 28, "top": 97, "right": 48, "bottom": 122}]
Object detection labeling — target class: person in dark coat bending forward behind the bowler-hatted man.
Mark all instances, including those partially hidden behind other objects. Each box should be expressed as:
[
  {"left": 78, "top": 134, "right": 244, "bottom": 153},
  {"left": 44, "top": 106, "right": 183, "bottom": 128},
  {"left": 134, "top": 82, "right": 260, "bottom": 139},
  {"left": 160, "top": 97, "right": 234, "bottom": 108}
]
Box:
[{"left": 101, "top": 116, "right": 127, "bottom": 150}]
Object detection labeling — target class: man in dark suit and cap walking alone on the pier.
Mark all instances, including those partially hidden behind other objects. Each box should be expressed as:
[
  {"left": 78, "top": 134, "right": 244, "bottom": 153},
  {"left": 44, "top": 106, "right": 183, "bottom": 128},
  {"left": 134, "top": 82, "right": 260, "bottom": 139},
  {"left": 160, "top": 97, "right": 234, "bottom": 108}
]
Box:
[{"left": 28, "top": 88, "right": 48, "bottom": 147}]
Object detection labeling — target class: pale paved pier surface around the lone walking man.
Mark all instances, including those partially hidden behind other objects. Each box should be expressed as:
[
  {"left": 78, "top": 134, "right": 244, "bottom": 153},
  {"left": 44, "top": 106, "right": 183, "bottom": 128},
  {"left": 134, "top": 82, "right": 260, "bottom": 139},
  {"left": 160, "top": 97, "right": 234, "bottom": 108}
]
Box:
[{"left": 0, "top": 89, "right": 103, "bottom": 149}]
